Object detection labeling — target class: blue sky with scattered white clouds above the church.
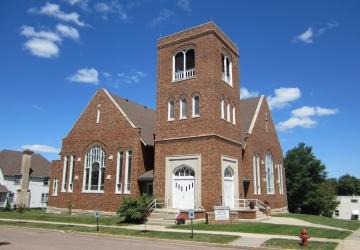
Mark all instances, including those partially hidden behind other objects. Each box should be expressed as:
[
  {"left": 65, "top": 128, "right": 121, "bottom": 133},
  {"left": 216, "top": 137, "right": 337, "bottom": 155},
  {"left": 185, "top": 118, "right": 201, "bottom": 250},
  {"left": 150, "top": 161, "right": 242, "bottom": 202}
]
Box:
[{"left": 0, "top": 0, "right": 360, "bottom": 177}]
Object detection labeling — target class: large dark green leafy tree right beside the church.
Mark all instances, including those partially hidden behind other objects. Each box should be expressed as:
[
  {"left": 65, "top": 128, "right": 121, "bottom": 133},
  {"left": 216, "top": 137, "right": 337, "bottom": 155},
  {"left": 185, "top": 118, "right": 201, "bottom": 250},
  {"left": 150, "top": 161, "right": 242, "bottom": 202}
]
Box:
[{"left": 284, "top": 143, "right": 337, "bottom": 215}]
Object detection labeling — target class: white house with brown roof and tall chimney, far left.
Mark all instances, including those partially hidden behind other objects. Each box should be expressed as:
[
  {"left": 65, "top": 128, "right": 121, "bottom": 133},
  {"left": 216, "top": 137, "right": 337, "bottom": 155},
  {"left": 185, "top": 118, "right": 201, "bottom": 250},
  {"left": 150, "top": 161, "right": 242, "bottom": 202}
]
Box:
[{"left": 0, "top": 150, "right": 50, "bottom": 208}]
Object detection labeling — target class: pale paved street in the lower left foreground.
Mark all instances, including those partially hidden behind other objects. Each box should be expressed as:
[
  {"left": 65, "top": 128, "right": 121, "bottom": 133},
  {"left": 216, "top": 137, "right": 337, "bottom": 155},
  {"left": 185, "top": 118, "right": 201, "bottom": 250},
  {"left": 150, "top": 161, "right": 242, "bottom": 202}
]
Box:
[{"left": 0, "top": 226, "right": 242, "bottom": 250}]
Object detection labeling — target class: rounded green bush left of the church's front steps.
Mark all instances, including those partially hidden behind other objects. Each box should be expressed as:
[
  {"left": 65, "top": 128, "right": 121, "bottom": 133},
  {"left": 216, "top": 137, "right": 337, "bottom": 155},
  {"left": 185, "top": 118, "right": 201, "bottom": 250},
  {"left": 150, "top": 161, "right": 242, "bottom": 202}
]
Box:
[{"left": 117, "top": 195, "right": 153, "bottom": 223}]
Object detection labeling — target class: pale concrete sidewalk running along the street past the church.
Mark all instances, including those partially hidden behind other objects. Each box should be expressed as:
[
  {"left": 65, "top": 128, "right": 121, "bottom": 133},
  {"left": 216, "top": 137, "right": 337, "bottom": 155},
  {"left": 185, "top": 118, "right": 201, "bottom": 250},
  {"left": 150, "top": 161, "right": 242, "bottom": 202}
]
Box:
[{"left": 0, "top": 218, "right": 344, "bottom": 249}]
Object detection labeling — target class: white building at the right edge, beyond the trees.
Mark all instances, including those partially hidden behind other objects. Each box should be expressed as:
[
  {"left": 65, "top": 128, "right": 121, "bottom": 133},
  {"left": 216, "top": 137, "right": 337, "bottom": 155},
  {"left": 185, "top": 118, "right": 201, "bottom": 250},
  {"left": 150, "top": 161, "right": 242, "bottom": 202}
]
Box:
[{"left": 334, "top": 195, "right": 360, "bottom": 220}]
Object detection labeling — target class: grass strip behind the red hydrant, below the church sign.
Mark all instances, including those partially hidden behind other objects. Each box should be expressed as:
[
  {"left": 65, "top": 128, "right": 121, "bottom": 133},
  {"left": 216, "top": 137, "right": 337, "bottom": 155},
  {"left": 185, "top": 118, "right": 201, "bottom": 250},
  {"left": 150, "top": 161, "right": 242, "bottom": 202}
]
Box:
[{"left": 171, "top": 222, "right": 351, "bottom": 239}]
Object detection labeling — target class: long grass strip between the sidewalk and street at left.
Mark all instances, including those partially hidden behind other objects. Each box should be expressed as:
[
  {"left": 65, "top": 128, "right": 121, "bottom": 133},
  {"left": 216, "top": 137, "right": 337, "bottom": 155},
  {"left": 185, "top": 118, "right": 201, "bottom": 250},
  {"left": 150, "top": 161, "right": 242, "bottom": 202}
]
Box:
[{"left": 0, "top": 221, "right": 240, "bottom": 244}]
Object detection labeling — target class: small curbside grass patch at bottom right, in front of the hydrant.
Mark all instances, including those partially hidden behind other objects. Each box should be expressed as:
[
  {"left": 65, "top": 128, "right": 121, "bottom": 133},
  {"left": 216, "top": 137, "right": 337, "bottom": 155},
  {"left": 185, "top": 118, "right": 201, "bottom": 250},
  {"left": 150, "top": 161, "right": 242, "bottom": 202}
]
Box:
[{"left": 263, "top": 239, "right": 337, "bottom": 250}]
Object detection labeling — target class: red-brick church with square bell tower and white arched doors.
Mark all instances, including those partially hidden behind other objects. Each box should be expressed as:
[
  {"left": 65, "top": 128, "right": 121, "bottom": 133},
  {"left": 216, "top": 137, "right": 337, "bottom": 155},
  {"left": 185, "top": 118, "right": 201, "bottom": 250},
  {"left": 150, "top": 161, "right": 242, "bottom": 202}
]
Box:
[{"left": 48, "top": 22, "right": 287, "bottom": 216}]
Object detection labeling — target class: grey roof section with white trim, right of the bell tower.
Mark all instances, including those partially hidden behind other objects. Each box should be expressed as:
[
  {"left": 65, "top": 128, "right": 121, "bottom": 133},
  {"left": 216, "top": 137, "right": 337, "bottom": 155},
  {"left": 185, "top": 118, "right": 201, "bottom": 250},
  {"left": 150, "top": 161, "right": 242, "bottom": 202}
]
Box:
[{"left": 240, "top": 96, "right": 264, "bottom": 142}]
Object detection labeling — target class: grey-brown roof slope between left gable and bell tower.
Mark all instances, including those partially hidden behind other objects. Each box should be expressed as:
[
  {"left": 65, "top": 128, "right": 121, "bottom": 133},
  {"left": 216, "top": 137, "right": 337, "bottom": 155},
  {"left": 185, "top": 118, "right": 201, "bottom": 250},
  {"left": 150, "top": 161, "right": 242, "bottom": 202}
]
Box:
[{"left": 104, "top": 89, "right": 155, "bottom": 145}]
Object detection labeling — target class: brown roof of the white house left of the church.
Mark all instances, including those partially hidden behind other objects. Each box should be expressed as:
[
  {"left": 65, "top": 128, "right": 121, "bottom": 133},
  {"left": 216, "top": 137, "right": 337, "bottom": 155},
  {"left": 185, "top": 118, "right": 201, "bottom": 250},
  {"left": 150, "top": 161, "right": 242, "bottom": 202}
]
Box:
[{"left": 0, "top": 149, "right": 50, "bottom": 177}]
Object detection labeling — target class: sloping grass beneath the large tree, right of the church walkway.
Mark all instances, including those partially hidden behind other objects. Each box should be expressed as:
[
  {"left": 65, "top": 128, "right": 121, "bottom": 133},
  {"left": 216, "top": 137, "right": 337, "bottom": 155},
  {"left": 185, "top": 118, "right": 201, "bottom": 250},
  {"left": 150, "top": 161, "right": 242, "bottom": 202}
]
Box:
[{"left": 273, "top": 213, "right": 360, "bottom": 230}]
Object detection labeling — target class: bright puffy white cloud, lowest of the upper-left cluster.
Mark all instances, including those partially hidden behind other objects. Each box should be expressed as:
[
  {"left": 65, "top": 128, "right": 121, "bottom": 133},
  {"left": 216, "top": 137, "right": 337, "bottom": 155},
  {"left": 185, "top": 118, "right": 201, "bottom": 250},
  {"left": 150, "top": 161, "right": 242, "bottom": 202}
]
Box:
[{"left": 24, "top": 38, "right": 60, "bottom": 58}]
